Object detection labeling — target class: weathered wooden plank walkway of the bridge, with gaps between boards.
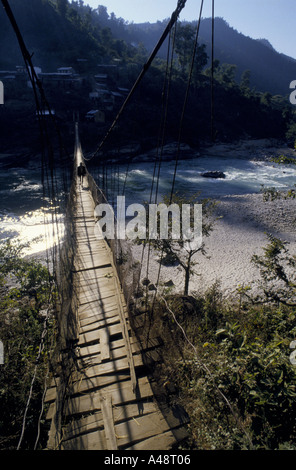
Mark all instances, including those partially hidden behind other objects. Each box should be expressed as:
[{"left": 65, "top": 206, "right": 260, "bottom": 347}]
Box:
[{"left": 46, "top": 129, "right": 186, "bottom": 450}]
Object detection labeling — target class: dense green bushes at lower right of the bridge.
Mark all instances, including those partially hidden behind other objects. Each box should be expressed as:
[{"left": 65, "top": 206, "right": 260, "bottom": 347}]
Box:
[{"left": 155, "top": 285, "right": 296, "bottom": 450}]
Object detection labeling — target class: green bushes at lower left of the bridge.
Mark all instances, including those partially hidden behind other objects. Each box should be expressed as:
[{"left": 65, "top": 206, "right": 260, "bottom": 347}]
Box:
[{"left": 0, "top": 242, "right": 54, "bottom": 450}]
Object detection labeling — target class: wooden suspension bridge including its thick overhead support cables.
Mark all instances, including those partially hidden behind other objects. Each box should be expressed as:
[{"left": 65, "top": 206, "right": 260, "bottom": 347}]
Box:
[{"left": 1, "top": 0, "right": 214, "bottom": 450}]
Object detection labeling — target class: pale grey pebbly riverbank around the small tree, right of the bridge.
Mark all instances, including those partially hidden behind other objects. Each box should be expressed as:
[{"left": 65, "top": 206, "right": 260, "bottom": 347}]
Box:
[{"left": 133, "top": 190, "right": 296, "bottom": 296}]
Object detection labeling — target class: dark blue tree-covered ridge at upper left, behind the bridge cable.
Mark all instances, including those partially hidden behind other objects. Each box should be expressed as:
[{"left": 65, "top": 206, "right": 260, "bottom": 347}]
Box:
[{"left": 0, "top": 0, "right": 140, "bottom": 71}]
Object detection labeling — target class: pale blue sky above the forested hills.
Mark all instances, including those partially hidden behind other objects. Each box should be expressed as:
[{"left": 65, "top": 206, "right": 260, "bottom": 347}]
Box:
[{"left": 84, "top": 0, "right": 296, "bottom": 59}]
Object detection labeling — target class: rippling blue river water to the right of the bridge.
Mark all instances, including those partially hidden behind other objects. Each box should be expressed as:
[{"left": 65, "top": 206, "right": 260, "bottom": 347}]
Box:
[{"left": 112, "top": 156, "right": 296, "bottom": 204}]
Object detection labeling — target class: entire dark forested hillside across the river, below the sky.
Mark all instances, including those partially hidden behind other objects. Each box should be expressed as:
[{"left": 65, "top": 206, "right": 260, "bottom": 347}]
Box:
[{"left": 0, "top": 0, "right": 296, "bottom": 149}]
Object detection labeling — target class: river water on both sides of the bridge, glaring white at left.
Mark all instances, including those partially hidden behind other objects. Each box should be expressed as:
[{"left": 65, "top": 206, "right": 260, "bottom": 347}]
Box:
[{"left": 0, "top": 156, "right": 296, "bottom": 253}]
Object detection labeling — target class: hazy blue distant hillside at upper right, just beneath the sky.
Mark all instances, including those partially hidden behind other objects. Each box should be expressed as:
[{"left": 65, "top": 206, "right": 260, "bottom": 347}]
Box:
[{"left": 127, "top": 18, "right": 296, "bottom": 96}]
